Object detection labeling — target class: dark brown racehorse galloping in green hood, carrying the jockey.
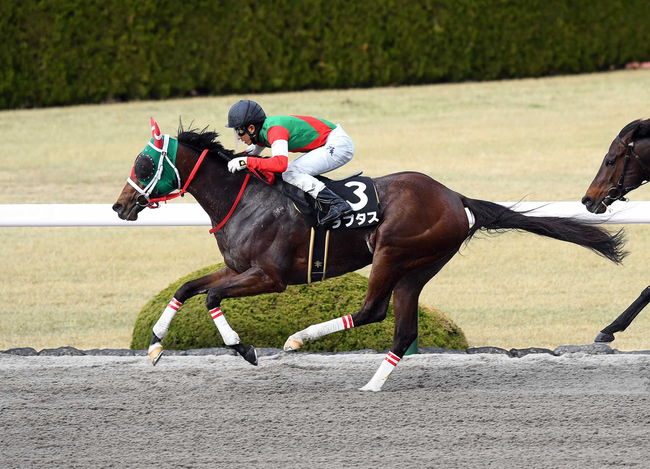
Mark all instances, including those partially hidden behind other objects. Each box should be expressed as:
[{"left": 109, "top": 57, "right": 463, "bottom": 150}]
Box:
[{"left": 113, "top": 119, "right": 625, "bottom": 391}]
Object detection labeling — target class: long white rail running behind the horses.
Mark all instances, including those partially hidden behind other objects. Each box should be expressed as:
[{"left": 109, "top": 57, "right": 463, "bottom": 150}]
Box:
[{"left": 0, "top": 201, "right": 650, "bottom": 226}]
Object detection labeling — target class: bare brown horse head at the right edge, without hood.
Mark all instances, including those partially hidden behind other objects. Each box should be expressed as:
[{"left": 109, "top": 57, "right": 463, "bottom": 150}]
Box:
[{"left": 582, "top": 119, "right": 650, "bottom": 213}]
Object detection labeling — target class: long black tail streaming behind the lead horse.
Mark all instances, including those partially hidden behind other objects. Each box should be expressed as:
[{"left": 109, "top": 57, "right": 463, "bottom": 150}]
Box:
[{"left": 462, "top": 197, "right": 627, "bottom": 264}]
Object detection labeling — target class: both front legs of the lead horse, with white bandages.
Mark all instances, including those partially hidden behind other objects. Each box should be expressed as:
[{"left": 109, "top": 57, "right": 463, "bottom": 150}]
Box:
[{"left": 149, "top": 267, "right": 284, "bottom": 365}]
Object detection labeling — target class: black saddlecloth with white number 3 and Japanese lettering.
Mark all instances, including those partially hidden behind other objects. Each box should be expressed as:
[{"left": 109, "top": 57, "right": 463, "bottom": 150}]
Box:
[{"left": 276, "top": 172, "right": 380, "bottom": 230}]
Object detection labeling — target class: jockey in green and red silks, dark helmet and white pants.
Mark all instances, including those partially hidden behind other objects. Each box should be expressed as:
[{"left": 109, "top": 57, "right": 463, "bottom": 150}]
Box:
[{"left": 227, "top": 99, "right": 354, "bottom": 225}]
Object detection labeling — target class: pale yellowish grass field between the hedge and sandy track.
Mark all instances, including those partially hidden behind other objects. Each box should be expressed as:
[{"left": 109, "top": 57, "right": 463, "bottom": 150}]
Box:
[{"left": 0, "top": 67, "right": 650, "bottom": 349}]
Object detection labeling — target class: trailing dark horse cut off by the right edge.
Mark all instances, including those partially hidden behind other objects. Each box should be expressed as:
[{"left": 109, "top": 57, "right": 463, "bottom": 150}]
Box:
[{"left": 582, "top": 119, "right": 650, "bottom": 343}]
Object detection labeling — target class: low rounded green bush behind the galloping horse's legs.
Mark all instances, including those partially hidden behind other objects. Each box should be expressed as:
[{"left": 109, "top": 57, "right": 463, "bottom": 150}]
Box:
[{"left": 131, "top": 264, "right": 467, "bottom": 352}]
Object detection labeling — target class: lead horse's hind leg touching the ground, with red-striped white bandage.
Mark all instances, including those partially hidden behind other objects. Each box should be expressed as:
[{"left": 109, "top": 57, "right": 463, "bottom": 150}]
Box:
[{"left": 359, "top": 256, "right": 453, "bottom": 392}]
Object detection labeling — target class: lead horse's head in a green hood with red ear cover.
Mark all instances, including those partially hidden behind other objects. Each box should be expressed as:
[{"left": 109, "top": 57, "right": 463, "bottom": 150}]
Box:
[{"left": 113, "top": 118, "right": 181, "bottom": 221}]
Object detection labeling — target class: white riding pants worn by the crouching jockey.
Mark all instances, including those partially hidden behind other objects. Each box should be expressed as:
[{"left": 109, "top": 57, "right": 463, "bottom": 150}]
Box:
[{"left": 282, "top": 125, "right": 354, "bottom": 199}]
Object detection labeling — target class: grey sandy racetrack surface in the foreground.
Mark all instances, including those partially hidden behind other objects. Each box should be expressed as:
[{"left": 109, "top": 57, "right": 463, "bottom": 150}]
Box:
[{"left": 0, "top": 353, "right": 650, "bottom": 468}]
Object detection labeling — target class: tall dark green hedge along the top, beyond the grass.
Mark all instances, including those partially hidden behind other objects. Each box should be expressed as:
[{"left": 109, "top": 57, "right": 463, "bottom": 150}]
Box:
[{"left": 0, "top": 0, "right": 650, "bottom": 108}]
